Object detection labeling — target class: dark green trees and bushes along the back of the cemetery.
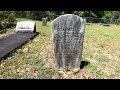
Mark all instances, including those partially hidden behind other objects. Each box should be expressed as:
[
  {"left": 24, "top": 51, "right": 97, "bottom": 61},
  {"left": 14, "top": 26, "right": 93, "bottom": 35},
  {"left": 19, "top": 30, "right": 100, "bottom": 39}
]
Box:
[{"left": 0, "top": 11, "right": 120, "bottom": 30}]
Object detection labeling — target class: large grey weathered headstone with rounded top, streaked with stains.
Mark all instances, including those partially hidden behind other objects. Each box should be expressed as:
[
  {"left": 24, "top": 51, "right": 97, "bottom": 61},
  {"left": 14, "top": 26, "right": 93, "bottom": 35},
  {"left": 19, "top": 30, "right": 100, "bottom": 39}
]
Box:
[{"left": 52, "top": 14, "right": 86, "bottom": 69}]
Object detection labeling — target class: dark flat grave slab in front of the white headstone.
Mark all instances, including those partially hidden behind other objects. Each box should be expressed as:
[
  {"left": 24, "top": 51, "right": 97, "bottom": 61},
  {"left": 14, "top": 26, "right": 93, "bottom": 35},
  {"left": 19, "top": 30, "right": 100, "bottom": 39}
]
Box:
[{"left": 0, "top": 32, "right": 38, "bottom": 61}]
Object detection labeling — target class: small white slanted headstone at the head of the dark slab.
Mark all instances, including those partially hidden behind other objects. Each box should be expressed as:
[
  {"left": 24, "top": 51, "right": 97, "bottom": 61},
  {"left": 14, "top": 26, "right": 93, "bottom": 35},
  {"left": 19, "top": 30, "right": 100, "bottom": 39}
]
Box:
[{"left": 16, "top": 21, "right": 36, "bottom": 33}]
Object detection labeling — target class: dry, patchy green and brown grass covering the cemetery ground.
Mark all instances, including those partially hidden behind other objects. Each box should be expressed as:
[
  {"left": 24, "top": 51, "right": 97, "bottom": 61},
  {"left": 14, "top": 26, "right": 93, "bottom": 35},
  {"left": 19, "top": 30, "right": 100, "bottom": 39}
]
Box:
[{"left": 0, "top": 18, "right": 120, "bottom": 79}]
